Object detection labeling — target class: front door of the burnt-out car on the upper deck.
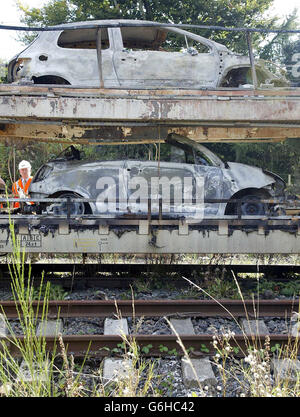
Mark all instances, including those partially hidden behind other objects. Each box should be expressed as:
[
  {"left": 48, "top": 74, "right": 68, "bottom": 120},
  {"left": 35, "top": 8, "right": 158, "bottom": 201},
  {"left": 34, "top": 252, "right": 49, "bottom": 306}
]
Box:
[{"left": 113, "top": 27, "right": 219, "bottom": 88}]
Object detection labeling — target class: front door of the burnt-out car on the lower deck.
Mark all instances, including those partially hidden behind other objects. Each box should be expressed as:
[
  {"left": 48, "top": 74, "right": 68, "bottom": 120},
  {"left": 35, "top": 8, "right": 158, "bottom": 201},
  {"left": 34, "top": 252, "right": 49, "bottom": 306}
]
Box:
[{"left": 126, "top": 144, "right": 204, "bottom": 218}]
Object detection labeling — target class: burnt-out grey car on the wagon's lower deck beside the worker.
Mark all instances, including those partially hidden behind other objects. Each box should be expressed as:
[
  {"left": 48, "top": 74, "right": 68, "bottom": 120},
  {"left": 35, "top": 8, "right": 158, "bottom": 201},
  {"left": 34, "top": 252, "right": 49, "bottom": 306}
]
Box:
[{"left": 29, "top": 134, "right": 285, "bottom": 218}]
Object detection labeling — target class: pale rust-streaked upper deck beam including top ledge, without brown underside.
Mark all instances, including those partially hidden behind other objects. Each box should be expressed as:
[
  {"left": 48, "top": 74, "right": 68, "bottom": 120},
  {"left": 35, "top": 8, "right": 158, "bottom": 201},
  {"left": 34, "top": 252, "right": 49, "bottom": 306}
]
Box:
[{"left": 0, "top": 86, "right": 300, "bottom": 119}]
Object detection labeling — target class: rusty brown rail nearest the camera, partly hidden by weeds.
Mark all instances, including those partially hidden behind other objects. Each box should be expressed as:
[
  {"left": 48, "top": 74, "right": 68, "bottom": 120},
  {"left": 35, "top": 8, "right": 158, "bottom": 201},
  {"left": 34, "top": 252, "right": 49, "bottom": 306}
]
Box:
[{"left": 7, "top": 334, "right": 299, "bottom": 357}]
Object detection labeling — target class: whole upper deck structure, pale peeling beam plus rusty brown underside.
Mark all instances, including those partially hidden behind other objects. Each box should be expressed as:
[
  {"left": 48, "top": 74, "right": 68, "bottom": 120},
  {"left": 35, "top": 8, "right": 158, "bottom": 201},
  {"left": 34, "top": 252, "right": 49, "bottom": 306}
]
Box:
[{"left": 0, "top": 85, "right": 300, "bottom": 144}]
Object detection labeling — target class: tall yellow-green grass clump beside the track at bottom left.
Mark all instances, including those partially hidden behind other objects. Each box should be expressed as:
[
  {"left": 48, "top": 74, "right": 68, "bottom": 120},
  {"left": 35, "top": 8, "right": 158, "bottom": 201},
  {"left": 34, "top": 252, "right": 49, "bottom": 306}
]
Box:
[{"left": 0, "top": 218, "right": 55, "bottom": 397}]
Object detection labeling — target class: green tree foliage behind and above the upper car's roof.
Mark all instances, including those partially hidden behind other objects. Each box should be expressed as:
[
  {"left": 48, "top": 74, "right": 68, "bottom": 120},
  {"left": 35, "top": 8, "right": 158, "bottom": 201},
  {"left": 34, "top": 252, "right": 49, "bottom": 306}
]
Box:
[{"left": 18, "top": 0, "right": 296, "bottom": 53}]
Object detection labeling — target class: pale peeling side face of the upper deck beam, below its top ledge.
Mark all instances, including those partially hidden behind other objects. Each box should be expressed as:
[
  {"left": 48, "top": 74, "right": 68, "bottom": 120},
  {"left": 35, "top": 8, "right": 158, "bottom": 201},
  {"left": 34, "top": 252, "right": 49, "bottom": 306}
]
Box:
[{"left": 0, "top": 95, "right": 300, "bottom": 127}]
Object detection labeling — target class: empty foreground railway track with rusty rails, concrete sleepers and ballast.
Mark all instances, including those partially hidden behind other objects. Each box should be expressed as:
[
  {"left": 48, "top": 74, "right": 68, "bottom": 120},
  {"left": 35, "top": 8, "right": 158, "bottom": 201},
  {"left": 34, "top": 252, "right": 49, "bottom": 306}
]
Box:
[{"left": 0, "top": 288, "right": 300, "bottom": 392}]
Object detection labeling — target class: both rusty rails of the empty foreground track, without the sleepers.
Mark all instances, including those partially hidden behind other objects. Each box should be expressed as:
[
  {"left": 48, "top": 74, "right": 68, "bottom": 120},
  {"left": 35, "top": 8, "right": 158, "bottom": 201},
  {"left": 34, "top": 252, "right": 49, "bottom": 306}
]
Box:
[{"left": 0, "top": 300, "right": 299, "bottom": 358}]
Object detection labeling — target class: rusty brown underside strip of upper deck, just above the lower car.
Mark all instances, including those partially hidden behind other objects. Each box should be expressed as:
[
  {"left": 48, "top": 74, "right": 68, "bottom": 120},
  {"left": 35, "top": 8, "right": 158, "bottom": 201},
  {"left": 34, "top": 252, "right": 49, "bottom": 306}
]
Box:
[{"left": 0, "top": 123, "right": 300, "bottom": 145}]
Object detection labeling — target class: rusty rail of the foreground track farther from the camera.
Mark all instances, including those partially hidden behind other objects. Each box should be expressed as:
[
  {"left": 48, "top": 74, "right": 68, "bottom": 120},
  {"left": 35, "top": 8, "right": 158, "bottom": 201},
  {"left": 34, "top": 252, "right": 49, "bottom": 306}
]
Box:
[{"left": 0, "top": 298, "right": 299, "bottom": 318}]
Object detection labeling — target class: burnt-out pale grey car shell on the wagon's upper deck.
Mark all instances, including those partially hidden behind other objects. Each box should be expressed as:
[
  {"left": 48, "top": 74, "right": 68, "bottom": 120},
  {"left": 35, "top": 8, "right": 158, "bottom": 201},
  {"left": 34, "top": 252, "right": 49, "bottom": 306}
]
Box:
[{"left": 8, "top": 20, "right": 289, "bottom": 89}]
